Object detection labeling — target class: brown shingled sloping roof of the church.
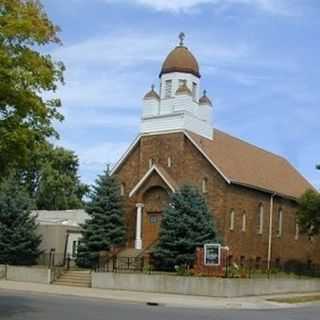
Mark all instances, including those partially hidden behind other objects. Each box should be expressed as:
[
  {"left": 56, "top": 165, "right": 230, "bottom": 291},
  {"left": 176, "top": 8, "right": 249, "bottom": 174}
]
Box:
[{"left": 188, "top": 129, "right": 314, "bottom": 198}]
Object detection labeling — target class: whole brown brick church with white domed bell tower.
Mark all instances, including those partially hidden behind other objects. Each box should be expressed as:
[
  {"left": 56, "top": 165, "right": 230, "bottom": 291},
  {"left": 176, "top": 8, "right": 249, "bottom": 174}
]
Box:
[{"left": 113, "top": 34, "right": 320, "bottom": 263}]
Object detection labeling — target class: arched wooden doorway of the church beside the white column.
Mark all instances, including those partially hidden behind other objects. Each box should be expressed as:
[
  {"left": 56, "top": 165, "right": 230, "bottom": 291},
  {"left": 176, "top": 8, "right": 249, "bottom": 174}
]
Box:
[{"left": 143, "top": 186, "right": 169, "bottom": 248}]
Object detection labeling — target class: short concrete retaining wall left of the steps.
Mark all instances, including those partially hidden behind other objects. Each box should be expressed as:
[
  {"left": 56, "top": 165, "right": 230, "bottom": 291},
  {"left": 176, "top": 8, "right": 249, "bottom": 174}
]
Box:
[{"left": 6, "top": 266, "right": 50, "bottom": 283}]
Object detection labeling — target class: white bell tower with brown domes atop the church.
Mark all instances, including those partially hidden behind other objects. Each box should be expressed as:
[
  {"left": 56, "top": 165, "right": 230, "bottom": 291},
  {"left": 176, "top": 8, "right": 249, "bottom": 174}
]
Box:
[{"left": 141, "top": 33, "right": 213, "bottom": 139}]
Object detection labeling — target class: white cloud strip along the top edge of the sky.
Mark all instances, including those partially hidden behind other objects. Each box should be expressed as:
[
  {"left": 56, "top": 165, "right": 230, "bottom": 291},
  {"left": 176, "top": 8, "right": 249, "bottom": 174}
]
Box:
[{"left": 102, "top": 0, "right": 295, "bottom": 15}]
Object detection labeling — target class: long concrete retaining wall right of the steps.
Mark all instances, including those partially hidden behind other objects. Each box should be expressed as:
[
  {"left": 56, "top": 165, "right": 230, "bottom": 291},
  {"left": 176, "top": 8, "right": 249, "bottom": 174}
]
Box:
[{"left": 92, "top": 272, "right": 320, "bottom": 297}]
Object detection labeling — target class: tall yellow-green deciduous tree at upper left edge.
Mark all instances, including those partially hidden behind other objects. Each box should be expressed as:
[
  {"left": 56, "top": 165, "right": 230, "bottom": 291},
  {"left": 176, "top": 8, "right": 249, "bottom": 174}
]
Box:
[{"left": 0, "top": 0, "right": 64, "bottom": 176}]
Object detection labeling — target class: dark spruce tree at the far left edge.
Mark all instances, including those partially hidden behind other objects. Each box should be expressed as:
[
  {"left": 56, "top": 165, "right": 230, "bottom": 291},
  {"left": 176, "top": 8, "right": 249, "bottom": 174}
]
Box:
[{"left": 0, "top": 174, "right": 41, "bottom": 265}]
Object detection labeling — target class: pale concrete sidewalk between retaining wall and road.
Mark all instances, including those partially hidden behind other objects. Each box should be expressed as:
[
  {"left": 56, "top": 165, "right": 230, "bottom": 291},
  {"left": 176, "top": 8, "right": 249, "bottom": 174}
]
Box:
[{"left": 0, "top": 280, "right": 315, "bottom": 309}]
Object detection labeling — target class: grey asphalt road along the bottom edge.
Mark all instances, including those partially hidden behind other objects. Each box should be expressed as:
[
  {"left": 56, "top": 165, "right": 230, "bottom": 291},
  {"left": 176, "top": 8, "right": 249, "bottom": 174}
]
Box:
[{"left": 0, "top": 290, "right": 320, "bottom": 320}]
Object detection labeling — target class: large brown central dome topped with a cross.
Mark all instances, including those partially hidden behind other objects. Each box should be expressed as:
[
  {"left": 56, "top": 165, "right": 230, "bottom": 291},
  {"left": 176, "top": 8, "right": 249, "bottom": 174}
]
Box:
[{"left": 159, "top": 33, "right": 200, "bottom": 78}]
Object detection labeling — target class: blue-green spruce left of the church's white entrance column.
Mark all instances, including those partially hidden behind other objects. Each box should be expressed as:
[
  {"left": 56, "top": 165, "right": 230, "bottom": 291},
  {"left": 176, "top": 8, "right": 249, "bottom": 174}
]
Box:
[{"left": 77, "top": 169, "right": 126, "bottom": 267}]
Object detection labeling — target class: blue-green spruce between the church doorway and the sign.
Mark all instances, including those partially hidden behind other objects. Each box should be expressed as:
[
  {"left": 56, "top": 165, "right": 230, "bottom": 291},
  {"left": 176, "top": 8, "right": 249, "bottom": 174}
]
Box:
[{"left": 153, "top": 185, "right": 217, "bottom": 270}]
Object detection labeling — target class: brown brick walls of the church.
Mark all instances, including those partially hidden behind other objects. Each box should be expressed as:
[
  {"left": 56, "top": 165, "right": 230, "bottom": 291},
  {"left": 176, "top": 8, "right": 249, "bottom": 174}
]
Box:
[{"left": 116, "top": 133, "right": 320, "bottom": 263}]
